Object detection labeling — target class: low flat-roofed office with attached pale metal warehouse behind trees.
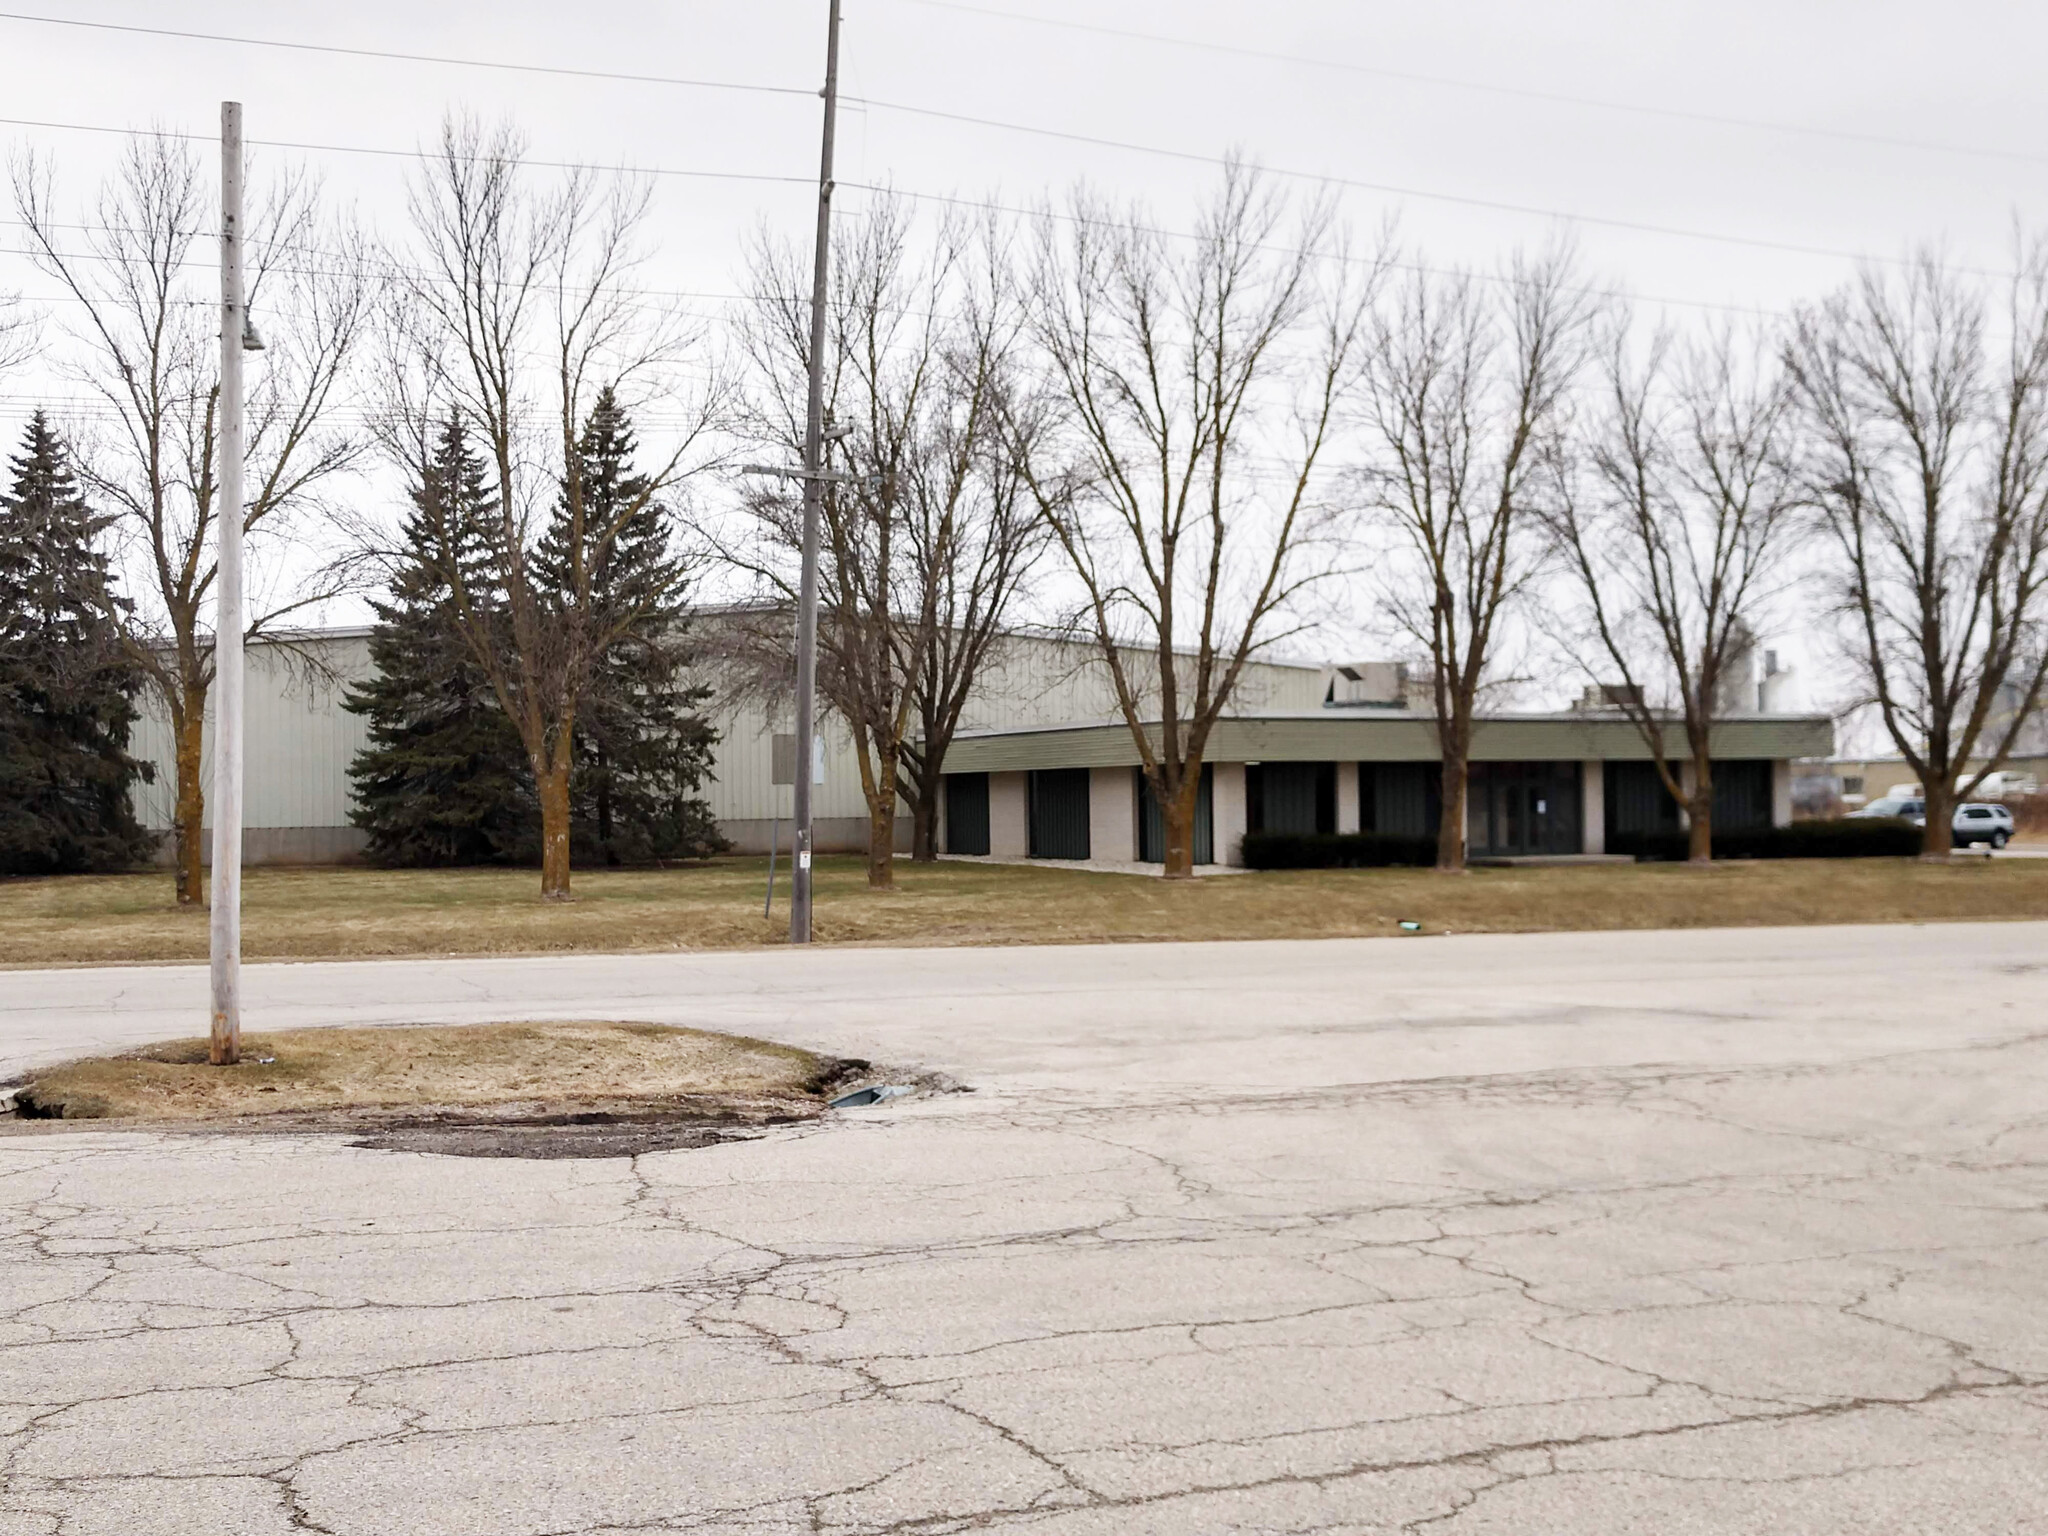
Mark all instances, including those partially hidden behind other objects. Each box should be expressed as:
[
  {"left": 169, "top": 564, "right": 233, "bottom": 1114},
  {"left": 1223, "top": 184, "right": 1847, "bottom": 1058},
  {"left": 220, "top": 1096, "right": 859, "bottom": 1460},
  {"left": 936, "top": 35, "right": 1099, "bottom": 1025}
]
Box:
[{"left": 133, "top": 629, "right": 1833, "bottom": 864}]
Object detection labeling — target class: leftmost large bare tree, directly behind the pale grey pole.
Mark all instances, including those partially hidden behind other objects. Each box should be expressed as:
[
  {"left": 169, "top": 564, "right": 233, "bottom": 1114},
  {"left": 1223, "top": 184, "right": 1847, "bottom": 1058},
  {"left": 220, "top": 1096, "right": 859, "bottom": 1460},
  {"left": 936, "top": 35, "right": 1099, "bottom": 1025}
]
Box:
[{"left": 14, "top": 135, "right": 371, "bottom": 903}]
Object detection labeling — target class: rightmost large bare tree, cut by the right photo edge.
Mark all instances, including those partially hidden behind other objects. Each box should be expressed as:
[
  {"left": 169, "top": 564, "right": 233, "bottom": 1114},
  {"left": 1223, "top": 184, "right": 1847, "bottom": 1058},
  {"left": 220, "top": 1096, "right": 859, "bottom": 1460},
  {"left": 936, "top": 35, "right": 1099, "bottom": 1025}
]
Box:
[{"left": 1790, "top": 244, "right": 2048, "bottom": 858}]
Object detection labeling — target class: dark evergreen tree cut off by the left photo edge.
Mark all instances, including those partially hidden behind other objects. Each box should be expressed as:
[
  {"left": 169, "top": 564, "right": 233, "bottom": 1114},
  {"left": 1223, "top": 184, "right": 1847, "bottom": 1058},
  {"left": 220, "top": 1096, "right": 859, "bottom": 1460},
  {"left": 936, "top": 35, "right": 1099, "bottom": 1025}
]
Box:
[{"left": 0, "top": 412, "right": 152, "bottom": 874}]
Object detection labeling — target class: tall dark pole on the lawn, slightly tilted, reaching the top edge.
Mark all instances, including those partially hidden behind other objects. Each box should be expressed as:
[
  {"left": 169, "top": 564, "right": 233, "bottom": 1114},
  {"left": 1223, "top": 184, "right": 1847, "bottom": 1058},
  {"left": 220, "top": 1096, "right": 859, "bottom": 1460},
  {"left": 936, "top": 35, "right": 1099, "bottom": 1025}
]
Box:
[{"left": 788, "top": 0, "right": 840, "bottom": 944}]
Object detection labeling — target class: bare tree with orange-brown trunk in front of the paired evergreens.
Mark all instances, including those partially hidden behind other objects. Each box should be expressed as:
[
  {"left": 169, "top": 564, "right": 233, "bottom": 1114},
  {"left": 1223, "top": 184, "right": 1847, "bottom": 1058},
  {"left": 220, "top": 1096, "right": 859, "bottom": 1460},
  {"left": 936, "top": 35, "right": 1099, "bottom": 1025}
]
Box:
[{"left": 383, "top": 119, "right": 721, "bottom": 901}]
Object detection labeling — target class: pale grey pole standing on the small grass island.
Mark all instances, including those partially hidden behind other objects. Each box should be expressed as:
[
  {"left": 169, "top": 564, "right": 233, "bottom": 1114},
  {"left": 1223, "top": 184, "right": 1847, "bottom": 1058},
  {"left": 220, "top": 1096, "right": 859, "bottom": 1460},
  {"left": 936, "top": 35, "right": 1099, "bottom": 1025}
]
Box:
[{"left": 207, "top": 100, "right": 254, "bottom": 1067}]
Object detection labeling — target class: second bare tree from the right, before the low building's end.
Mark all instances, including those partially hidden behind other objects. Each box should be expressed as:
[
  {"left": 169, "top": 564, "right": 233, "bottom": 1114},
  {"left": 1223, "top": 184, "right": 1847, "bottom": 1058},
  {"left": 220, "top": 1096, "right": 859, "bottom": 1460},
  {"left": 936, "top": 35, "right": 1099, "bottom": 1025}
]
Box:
[{"left": 1548, "top": 326, "right": 1798, "bottom": 862}]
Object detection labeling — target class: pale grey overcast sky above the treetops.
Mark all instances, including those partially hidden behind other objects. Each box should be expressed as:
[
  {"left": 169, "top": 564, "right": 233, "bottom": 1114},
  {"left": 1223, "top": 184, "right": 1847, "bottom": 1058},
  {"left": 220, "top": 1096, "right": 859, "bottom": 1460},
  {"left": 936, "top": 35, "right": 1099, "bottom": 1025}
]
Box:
[{"left": 0, "top": 0, "right": 2048, "bottom": 729}]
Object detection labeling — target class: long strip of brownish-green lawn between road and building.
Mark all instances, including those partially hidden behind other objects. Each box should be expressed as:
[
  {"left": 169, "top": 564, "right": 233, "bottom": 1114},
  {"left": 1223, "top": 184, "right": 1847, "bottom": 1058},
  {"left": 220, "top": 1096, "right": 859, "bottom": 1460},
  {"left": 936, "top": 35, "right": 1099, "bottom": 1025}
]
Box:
[{"left": 0, "top": 858, "right": 2048, "bottom": 967}]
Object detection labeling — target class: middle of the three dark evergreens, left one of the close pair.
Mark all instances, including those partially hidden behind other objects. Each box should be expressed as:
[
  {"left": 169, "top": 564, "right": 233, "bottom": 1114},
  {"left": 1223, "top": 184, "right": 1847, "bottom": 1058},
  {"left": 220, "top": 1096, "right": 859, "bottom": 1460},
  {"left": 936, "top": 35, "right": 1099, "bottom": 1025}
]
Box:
[{"left": 344, "top": 420, "right": 539, "bottom": 864}]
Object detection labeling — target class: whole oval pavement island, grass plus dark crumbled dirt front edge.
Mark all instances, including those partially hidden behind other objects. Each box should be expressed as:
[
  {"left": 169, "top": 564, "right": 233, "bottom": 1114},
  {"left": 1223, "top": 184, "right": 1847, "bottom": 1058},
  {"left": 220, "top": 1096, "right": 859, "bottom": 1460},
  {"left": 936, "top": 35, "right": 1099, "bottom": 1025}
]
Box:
[{"left": 14, "top": 1022, "right": 868, "bottom": 1157}]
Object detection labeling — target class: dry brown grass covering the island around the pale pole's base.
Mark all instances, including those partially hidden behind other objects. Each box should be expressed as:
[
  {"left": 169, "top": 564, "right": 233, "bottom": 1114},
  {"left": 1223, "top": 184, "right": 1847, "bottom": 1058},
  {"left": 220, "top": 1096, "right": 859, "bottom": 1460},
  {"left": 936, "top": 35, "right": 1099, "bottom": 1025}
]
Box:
[{"left": 23, "top": 1022, "right": 831, "bottom": 1120}]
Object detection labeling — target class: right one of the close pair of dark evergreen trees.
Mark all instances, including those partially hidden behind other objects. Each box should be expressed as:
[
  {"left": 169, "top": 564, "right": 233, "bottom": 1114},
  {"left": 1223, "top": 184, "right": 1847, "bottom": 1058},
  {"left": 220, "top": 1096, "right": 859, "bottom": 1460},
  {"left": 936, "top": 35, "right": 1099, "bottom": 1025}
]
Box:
[{"left": 537, "top": 389, "right": 727, "bottom": 864}]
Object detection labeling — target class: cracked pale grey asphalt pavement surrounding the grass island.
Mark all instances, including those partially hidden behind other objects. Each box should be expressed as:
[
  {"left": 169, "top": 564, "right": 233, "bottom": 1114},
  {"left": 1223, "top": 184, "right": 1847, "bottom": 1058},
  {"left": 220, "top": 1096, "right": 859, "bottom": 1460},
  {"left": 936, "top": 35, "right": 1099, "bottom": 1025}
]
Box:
[{"left": 0, "top": 924, "right": 2048, "bottom": 1536}]
